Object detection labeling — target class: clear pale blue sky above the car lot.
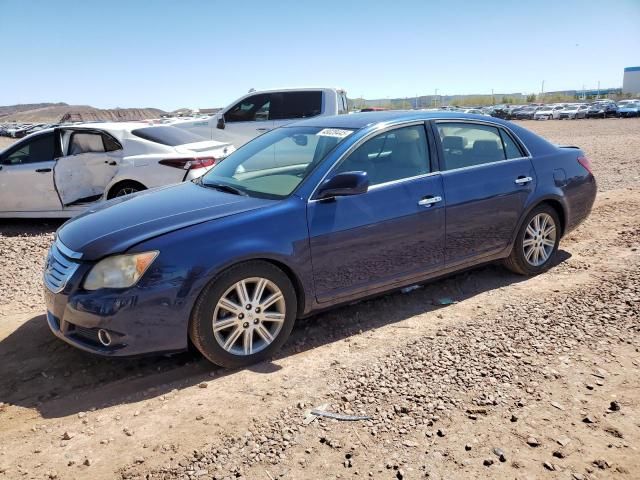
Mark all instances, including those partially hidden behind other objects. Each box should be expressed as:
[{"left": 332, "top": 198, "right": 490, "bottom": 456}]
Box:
[{"left": 0, "top": 0, "right": 640, "bottom": 110}]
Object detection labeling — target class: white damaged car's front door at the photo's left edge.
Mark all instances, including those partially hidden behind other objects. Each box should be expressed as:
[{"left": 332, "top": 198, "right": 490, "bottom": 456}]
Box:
[{"left": 0, "top": 132, "right": 62, "bottom": 213}]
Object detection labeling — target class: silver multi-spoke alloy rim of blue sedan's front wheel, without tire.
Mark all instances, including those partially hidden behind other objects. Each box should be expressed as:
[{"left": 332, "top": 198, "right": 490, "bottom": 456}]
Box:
[{"left": 213, "top": 277, "right": 286, "bottom": 356}]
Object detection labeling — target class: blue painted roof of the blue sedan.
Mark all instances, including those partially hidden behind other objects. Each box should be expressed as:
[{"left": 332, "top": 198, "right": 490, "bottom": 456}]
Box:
[{"left": 288, "top": 110, "right": 504, "bottom": 130}]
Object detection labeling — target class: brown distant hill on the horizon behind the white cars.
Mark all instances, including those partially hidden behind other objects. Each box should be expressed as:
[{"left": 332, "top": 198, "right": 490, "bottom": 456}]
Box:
[{"left": 0, "top": 103, "right": 165, "bottom": 123}]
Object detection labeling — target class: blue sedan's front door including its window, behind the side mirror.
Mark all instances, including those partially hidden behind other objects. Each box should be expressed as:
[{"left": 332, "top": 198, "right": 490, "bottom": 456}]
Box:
[{"left": 307, "top": 124, "right": 445, "bottom": 302}]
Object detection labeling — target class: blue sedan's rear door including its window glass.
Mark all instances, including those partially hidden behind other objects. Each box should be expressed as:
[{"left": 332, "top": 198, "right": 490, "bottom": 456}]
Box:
[{"left": 434, "top": 121, "right": 536, "bottom": 266}]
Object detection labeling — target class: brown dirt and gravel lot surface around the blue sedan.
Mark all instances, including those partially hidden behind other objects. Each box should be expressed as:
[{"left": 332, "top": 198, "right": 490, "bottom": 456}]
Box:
[{"left": 0, "top": 119, "right": 640, "bottom": 480}]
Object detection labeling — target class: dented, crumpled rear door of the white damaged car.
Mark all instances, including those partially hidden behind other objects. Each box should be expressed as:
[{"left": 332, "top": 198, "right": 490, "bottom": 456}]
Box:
[{"left": 54, "top": 130, "right": 122, "bottom": 205}]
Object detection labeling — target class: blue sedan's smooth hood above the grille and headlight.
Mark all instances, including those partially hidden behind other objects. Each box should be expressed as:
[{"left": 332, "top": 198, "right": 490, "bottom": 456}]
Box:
[{"left": 57, "top": 182, "right": 275, "bottom": 260}]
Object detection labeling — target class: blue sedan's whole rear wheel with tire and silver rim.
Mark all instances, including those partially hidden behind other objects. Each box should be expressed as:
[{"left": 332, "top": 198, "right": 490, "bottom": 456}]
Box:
[{"left": 505, "top": 205, "right": 560, "bottom": 275}]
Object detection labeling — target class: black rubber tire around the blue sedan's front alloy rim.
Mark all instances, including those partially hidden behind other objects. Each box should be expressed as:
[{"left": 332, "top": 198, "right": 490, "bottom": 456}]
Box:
[{"left": 189, "top": 260, "right": 297, "bottom": 368}]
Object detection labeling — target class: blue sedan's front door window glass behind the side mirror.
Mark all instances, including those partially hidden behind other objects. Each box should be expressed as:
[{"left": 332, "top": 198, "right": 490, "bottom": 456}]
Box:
[{"left": 334, "top": 125, "right": 431, "bottom": 186}]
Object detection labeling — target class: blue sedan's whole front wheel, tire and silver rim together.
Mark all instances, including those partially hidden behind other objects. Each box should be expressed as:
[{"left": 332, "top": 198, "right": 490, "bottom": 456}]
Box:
[{"left": 189, "top": 261, "right": 297, "bottom": 368}]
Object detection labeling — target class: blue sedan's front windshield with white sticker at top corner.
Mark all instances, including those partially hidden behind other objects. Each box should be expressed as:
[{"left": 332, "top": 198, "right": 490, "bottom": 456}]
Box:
[{"left": 198, "top": 127, "right": 353, "bottom": 199}]
